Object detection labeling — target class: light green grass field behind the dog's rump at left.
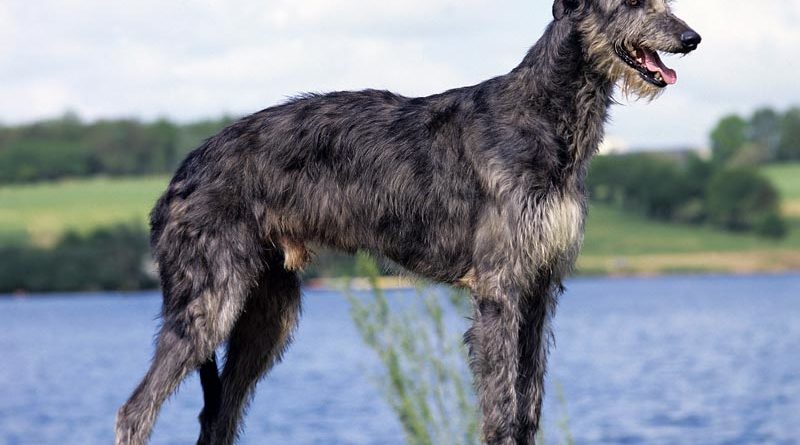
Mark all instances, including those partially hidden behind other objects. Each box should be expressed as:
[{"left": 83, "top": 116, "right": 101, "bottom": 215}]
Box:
[{"left": 0, "top": 177, "right": 168, "bottom": 245}]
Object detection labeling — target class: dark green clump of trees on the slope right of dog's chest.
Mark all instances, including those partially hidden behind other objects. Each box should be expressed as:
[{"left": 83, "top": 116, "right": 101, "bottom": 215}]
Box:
[{"left": 587, "top": 153, "right": 788, "bottom": 238}]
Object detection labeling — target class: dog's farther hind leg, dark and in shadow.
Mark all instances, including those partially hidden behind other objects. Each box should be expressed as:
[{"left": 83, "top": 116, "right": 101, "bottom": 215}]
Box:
[{"left": 201, "top": 263, "right": 300, "bottom": 445}]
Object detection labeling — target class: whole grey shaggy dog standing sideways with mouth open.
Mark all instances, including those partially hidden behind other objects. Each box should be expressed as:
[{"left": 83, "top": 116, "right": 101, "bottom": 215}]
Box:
[{"left": 116, "top": 0, "right": 700, "bottom": 445}]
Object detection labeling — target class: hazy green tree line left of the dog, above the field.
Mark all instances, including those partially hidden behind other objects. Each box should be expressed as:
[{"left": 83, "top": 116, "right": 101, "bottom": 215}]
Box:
[{"left": 0, "top": 113, "right": 233, "bottom": 184}]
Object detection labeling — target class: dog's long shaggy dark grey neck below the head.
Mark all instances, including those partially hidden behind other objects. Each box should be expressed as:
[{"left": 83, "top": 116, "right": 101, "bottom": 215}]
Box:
[{"left": 507, "top": 18, "right": 614, "bottom": 170}]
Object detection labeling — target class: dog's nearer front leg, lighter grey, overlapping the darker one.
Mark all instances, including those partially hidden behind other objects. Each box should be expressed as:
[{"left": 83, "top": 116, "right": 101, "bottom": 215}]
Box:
[{"left": 466, "top": 280, "right": 520, "bottom": 445}]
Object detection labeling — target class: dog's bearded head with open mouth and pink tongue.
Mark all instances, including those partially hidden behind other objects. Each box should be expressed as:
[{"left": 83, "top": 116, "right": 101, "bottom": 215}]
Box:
[{"left": 553, "top": 0, "right": 700, "bottom": 98}]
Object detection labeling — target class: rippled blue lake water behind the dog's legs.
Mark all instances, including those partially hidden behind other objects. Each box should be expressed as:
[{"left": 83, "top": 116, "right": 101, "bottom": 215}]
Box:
[{"left": 0, "top": 276, "right": 800, "bottom": 445}]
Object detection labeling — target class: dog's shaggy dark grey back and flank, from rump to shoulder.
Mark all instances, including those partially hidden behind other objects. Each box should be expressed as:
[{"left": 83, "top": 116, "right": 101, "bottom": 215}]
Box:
[{"left": 151, "top": 90, "right": 490, "bottom": 283}]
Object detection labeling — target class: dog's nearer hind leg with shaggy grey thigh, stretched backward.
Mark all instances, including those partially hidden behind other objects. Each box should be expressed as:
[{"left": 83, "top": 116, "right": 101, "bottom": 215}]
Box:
[{"left": 116, "top": 218, "right": 263, "bottom": 445}]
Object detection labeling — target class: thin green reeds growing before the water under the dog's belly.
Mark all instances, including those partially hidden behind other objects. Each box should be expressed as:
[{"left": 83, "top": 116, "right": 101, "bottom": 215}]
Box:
[{"left": 347, "top": 254, "right": 574, "bottom": 445}]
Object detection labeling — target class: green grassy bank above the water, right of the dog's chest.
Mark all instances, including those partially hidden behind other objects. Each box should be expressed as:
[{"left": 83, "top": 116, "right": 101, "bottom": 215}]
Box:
[{"left": 578, "top": 164, "right": 800, "bottom": 275}]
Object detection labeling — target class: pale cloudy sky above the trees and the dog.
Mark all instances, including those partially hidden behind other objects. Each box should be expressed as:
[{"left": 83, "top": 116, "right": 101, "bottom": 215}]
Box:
[{"left": 0, "top": 0, "right": 800, "bottom": 148}]
